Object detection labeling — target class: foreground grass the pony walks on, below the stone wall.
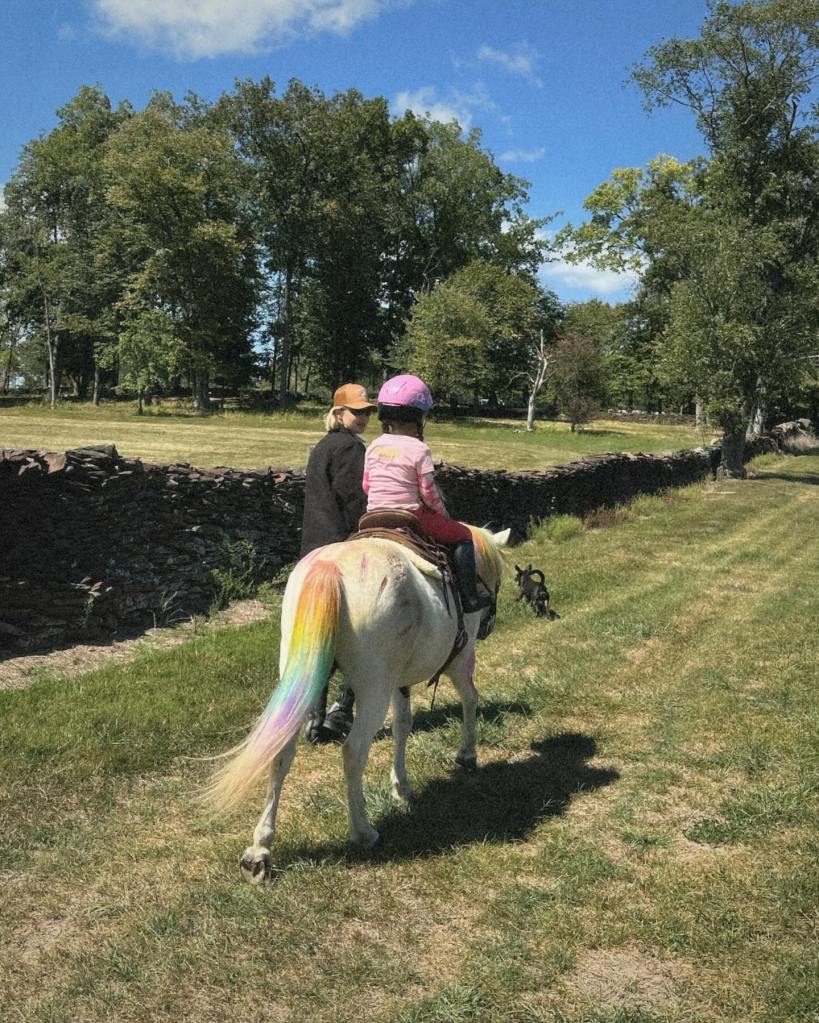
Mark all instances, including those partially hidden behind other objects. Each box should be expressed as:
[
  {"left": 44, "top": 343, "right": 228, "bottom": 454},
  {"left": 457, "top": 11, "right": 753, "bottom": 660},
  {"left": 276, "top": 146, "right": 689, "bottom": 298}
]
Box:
[{"left": 0, "top": 456, "right": 819, "bottom": 1023}]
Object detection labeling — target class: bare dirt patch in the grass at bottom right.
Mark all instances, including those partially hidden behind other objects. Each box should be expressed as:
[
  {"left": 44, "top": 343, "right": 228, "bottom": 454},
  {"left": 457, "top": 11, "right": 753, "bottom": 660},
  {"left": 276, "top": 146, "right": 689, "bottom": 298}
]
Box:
[{"left": 566, "top": 948, "right": 691, "bottom": 1009}]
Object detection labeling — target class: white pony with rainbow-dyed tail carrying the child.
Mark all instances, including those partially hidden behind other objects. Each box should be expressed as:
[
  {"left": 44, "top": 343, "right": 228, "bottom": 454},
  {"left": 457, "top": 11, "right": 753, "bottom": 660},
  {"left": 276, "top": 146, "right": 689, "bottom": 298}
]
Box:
[{"left": 208, "top": 526, "right": 509, "bottom": 883}]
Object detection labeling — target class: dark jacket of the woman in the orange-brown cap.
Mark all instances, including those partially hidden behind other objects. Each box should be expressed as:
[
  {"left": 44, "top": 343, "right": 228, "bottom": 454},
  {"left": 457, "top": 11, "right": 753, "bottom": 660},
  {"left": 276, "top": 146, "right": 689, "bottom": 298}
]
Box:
[{"left": 300, "top": 427, "right": 367, "bottom": 558}]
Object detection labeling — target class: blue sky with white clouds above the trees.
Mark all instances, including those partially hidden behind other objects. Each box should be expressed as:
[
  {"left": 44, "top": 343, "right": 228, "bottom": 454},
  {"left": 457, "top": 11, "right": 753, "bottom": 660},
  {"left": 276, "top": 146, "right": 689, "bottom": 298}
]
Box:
[{"left": 0, "top": 0, "right": 706, "bottom": 301}]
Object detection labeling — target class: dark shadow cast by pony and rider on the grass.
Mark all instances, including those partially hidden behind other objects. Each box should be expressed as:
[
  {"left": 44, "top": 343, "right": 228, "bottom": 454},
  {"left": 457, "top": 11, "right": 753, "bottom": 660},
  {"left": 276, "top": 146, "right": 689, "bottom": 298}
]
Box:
[{"left": 288, "top": 732, "right": 620, "bottom": 866}]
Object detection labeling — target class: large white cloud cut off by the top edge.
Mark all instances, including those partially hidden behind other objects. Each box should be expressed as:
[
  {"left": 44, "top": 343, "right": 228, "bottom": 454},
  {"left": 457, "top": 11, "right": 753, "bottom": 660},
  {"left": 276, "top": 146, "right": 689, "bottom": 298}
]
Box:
[{"left": 94, "top": 0, "right": 393, "bottom": 59}]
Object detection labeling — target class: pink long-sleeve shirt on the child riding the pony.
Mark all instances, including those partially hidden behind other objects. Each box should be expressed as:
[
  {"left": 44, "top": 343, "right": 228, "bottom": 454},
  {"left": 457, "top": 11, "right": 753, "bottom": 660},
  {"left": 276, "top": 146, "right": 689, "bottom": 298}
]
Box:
[{"left": 363, "top": 434, "right": 447, "bottom": 515}]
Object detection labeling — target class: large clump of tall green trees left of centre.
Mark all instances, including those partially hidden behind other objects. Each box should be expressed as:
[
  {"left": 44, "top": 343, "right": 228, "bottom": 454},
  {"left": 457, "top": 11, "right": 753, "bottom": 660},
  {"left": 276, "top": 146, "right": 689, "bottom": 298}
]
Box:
[{"left": 0, "top": 79, "right": 543, "bottom": 407}]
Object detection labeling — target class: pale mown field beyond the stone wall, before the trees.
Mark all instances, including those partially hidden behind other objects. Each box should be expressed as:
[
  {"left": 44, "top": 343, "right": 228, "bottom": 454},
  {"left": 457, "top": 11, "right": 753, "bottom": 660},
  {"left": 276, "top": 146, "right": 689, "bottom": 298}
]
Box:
[{"left": 0, "top": 405, "right": 713, "bottom": 469}]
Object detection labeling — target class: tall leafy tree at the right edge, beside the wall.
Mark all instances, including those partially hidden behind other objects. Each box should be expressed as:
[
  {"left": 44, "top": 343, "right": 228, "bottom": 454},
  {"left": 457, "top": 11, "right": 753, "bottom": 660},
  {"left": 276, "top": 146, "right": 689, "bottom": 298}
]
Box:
[{"left": 562, "top": 0, "right": 819, "bottom": 476}]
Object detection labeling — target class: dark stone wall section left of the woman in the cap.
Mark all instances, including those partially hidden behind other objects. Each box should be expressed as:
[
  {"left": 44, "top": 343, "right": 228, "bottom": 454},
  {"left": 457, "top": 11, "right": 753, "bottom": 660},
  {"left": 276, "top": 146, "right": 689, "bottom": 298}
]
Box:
[{"left": 0, "top": 446, "right": 304, "bottom": 649}]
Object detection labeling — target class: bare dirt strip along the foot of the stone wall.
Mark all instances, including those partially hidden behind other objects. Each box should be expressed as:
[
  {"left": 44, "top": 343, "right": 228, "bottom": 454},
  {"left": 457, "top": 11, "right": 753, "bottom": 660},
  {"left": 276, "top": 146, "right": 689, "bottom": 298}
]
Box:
[{"left": 0, "top": 601, "right": 271, "bottom": 690}]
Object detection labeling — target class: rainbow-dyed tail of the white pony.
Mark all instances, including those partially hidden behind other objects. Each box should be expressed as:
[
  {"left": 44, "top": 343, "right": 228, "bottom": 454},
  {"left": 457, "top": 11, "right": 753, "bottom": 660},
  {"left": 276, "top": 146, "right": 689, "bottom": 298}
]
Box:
[{"left": 206, "top": 560, "right": 342, "bottom": 809}]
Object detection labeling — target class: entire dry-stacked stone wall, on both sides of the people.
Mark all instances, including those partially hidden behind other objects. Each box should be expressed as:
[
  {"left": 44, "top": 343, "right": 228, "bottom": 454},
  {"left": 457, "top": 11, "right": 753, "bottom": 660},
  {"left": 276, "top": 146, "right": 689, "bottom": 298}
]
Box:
[{"left": 0, "top": 441, "right": 775, "bottom": 652}]
